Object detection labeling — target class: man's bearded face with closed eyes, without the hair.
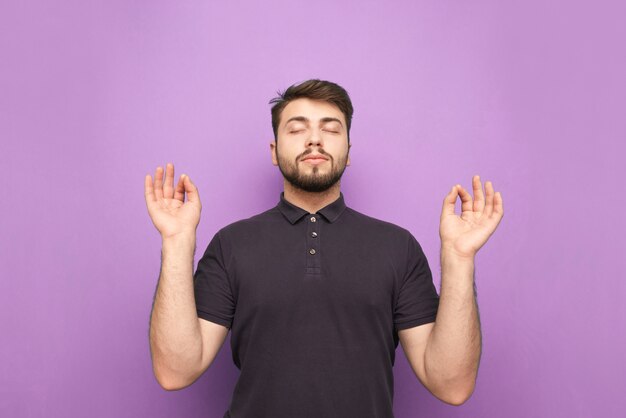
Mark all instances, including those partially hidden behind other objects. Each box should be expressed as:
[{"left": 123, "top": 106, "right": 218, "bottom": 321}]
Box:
[{"left": 270, "top": 98, "right": 350, "bottom": 192}]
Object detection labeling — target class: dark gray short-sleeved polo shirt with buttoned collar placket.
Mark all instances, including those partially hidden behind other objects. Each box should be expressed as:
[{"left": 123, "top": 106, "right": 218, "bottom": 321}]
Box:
[{"left": 194, "top": 193, "right": 439, "bottom": 418}]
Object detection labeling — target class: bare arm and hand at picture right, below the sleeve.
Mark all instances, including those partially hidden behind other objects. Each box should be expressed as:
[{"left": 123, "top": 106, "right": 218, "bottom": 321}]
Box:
[{"left": 398, "top": 175, "right": 504, "bottom": 405}]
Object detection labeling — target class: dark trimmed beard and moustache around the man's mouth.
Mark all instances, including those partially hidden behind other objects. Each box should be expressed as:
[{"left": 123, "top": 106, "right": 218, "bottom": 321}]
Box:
[{"left": 276, "top": 149, "right": 348, "bottom": 193}]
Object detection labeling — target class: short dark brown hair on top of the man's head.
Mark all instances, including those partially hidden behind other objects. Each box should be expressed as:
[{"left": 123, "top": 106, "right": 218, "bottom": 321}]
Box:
[{"left": 269, "top": 79, "right": 354, "bottom": 143}]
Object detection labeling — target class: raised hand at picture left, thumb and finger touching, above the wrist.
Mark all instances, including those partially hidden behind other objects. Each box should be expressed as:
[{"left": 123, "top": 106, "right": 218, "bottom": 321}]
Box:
[{"left": 145, "top": 163, "right": 202, "bottom": 239}]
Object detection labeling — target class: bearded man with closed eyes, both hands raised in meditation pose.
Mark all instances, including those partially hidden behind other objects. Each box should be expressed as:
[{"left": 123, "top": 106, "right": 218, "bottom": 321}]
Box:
[{"left": 145, "top": 80, "right": 503, "bottom": 418}]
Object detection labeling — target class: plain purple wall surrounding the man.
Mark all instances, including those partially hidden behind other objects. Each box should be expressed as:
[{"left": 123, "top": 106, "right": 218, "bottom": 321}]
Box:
[{"left": 0, "top": 0, "right": 626, "bottom": 418}]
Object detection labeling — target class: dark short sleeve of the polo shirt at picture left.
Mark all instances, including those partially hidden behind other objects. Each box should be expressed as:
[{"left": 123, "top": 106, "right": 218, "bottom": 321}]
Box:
[{"left": 193, "top": 232, "right": 235, "bottom": 328}]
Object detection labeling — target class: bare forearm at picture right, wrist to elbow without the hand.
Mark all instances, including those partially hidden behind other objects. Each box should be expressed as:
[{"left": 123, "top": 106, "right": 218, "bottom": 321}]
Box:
[{"left": 424, "top": 251, "right": 481, "bottom": 403}]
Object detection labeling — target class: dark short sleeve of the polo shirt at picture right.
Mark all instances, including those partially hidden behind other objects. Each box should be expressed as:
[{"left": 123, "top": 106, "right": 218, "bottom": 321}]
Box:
[{"left": 393, "top": 234, "right": 439, "bottom": 330}]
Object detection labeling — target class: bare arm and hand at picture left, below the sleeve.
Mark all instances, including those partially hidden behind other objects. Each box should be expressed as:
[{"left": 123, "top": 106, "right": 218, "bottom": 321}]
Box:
[{"left": 145, "top": 168, "right": 228, "bottom": 390}]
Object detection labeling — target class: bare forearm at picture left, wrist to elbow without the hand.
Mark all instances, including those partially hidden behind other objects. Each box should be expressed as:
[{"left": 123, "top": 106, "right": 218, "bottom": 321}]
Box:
[{"left": 150, "top": 234, "right": 202, "bottom": 387}]
